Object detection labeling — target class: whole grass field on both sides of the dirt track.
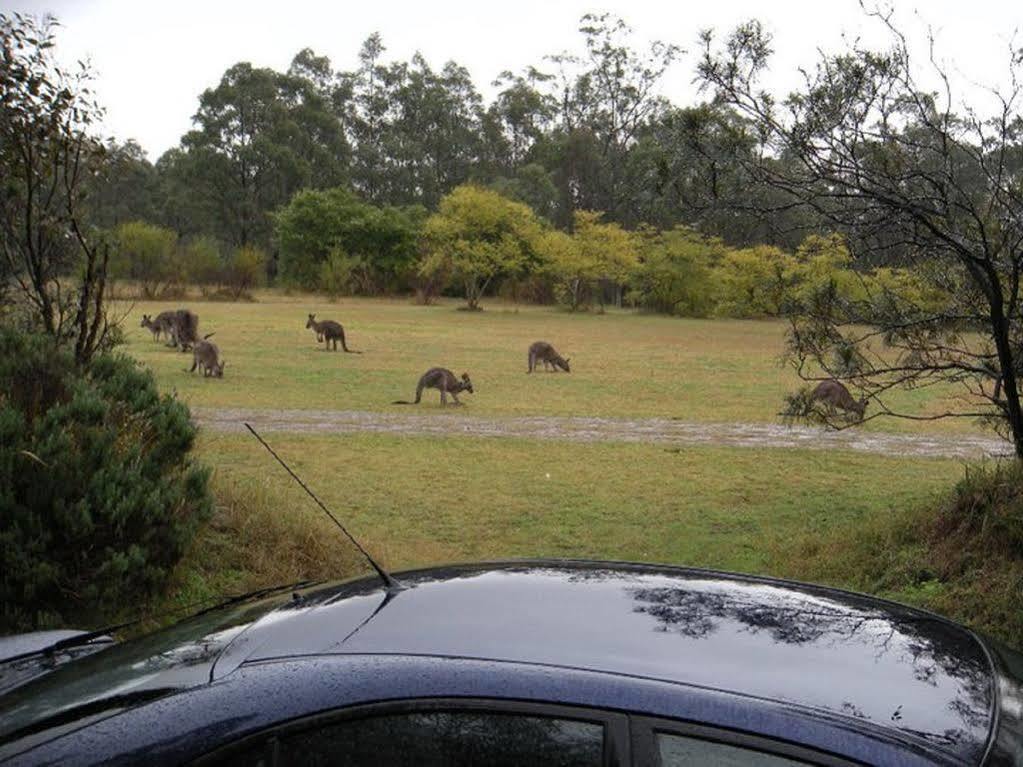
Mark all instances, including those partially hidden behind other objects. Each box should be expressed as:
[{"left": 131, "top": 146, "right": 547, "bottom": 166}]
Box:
[{"left": 117, "top": 294, "right": 1014, "bottom": 630}]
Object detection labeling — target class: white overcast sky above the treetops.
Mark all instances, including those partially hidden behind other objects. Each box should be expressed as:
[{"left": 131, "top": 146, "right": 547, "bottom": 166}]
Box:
[{"left": 4, "top": 0, "right": 1023, "bottom": 161}]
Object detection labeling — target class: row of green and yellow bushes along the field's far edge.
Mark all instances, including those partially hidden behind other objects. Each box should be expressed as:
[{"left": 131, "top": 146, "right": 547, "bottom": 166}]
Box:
[{"left": 114, "top": 184, "right": 938, "bottom": 317}]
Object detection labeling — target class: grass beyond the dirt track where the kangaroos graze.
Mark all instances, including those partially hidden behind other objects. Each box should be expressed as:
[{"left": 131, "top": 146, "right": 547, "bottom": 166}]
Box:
[{"left": 125, "top": 292, "right": 976, "bottom": 431}]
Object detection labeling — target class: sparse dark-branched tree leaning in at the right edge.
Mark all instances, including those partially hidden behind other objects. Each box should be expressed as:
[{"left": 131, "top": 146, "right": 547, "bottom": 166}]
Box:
[{"left": 700, "top": 13, "right": 1023, "bottom": 458}]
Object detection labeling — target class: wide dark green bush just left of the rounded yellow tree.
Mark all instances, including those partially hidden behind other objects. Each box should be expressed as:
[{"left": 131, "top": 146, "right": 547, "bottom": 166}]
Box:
[{"left": 274, "top": 187, "right": 425, "bottom": 292}]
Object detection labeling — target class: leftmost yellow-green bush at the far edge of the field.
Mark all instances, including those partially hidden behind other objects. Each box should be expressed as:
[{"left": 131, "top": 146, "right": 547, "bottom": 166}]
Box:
[{"left": 110, "top": 221, "right": 185, "bottom": 299}]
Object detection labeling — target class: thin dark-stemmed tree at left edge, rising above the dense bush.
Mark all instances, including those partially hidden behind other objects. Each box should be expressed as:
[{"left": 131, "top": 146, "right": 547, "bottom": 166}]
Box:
[{"left": 0, "top": 13, "right": 110, "bottom": 364}]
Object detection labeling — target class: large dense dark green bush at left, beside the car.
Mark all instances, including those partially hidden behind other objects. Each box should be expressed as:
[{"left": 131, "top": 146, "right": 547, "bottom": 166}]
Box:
[{"left": 0, "top": 327, "right": 212, "bottom": 629}]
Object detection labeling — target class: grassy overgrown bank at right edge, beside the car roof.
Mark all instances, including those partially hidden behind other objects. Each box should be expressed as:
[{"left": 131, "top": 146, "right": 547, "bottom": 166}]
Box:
[{"left": 774, "top": 461, "right": 1023, "bottom": 649}]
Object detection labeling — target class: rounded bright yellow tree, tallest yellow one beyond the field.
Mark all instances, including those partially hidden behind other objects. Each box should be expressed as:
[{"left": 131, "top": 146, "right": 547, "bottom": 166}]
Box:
[{"left": 419, "top": 185, "right": 540, "bottom": 310}]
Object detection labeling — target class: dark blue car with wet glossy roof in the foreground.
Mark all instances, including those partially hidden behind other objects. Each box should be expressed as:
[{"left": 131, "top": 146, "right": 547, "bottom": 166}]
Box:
[{"left": 0, "top": 561, "right": 1023, "bottom": 767}]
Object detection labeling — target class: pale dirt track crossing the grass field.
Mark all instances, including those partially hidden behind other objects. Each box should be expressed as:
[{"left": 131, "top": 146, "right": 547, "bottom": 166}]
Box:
[{"left": 192, "top": 408, "right": 1010, "bottom": 458}]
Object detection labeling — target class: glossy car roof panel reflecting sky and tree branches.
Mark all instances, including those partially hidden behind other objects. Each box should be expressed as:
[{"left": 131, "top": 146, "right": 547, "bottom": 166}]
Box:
[{"left": 213, "top": 561, "right": 995, "bottom": 761}]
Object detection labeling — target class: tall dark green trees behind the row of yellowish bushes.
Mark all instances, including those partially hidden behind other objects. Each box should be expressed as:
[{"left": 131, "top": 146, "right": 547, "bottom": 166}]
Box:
[{"left": 89, "top": 15, "right": 812, "bottom": 267}]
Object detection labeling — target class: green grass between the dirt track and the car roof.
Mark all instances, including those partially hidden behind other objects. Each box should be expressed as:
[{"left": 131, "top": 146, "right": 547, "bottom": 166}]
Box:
[{"left": 192, "top": 434, "right": 960, "bottom": 575}]
